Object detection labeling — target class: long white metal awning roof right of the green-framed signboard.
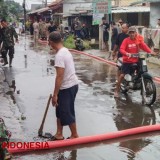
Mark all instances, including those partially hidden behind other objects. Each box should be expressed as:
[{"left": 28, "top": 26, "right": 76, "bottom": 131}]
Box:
[{"left": 112, "top": 6, "right": 150, "bottom": 13}]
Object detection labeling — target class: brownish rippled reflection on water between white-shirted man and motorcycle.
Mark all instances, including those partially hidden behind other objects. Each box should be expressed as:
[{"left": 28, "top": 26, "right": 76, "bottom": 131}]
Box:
[{"left": 74, "top": 55, "right": 116, "bottom": 86}]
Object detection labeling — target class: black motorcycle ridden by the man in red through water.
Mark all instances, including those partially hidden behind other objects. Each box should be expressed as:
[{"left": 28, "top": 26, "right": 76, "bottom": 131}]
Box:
[{"left": 120, "top": 53, "right": 156, "bottom": 106}]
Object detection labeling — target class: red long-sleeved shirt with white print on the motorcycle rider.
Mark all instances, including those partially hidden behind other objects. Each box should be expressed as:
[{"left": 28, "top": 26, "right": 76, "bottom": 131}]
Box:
[{"left": 120, "top": 37, "right": 151, "bottom": 63}]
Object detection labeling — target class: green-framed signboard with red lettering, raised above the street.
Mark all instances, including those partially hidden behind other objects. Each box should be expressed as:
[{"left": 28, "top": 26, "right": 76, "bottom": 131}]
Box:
[{"left": 92, "top": 0, "right": 111, "bottom": 25}]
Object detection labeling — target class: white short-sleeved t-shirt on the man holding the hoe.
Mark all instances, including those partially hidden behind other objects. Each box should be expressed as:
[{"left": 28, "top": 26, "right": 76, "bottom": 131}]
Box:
[{"left": 54, "top": 47, "right": 78, "bottom": 90}]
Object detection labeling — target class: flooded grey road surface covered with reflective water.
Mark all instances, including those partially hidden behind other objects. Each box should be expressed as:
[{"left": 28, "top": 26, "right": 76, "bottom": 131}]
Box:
[{"left": 1, "top": 37, "right": 160, "bottom": 160}]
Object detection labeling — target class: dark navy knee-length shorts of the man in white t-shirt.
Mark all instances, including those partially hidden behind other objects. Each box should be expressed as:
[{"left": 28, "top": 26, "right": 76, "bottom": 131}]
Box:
[{"left": 56, "top": 85, "right": 78, "bottom": 126}]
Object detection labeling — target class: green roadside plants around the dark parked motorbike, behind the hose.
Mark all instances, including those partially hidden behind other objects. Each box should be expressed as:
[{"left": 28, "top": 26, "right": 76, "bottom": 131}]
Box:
[{"left": 63, "top": 35, "right": 91, "bottom": 49}]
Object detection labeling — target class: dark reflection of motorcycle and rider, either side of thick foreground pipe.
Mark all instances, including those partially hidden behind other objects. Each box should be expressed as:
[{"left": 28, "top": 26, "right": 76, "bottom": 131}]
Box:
[{"left": 114, "top": 96, "right": 156, "bottom": 160}]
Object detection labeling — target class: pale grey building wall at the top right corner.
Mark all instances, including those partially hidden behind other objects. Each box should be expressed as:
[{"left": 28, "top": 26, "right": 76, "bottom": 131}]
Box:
[{"left": 150, "top": 2, "right": 160, "bottom": 28}]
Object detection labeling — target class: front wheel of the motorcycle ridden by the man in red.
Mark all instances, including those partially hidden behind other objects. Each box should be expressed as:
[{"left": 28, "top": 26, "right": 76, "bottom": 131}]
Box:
[{"left": 142, "top": 78, "right": 156, "bottom": 106}]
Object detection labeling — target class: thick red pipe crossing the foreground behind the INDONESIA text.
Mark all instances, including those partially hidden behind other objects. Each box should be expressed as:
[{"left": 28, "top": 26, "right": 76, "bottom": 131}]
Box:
[{"left": 8, "top": 125, "right": 160, "bottom": 153}]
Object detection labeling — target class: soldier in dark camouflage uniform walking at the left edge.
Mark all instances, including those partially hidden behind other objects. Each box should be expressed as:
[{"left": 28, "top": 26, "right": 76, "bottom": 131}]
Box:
[{"left": 1, "top": 19, "right": 18, "bottom": 67}]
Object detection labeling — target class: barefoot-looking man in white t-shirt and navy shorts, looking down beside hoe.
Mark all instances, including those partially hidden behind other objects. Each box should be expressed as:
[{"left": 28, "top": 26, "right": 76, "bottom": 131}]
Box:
[{"left": 49, "top": 31, "right": 78, "bottom": 140}]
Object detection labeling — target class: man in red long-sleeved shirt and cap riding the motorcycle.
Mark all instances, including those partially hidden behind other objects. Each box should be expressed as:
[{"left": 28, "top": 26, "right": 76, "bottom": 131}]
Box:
[{"left": 114, "top": 27, "right": 156, "bottom": 97}]
